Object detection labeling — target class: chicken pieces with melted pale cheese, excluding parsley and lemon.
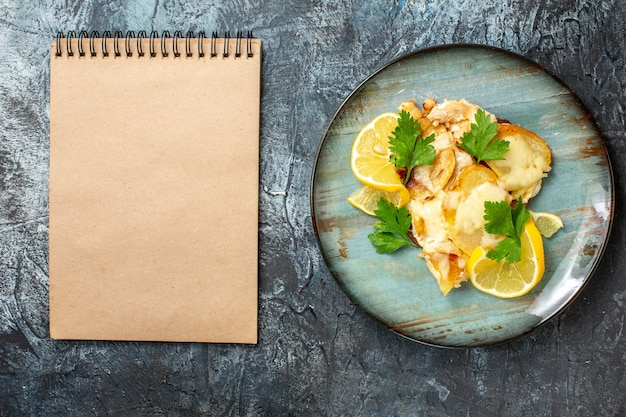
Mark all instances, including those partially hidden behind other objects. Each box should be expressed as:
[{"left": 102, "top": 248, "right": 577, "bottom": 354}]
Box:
[{"left": 399, "top": 99, "right": 552, "bottom": 295}]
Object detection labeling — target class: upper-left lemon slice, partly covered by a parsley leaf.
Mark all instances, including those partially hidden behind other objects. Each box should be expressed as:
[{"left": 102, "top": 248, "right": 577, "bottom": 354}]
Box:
[{"left": 350, "top": 113, "right": 411, "bottom": 206}]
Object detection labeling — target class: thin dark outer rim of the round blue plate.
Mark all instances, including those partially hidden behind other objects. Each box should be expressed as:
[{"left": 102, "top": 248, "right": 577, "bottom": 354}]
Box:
[{"left": 309, "top": 43, "right": 615, "bottom": 349}]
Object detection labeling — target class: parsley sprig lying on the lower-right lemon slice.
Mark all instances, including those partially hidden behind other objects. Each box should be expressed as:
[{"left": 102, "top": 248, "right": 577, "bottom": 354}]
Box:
[{"left": 484, "top": 198, "right": 530, "bottom": 263}]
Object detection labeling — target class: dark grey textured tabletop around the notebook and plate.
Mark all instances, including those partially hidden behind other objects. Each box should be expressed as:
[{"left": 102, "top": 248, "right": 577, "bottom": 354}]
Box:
[{"left": 0, "top": 0, "right": 626, "bottom": 417}]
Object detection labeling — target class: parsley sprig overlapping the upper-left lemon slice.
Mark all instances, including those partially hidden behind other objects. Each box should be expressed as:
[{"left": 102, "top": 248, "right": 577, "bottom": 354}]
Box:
[{"left": 389, "top": 110, "right": 437, "bottom": 184}]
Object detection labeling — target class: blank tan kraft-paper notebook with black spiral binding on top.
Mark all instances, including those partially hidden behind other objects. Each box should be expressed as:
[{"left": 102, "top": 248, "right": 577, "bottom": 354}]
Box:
[{"left": 49, "top": 31, "right": 261, "bottom": 343}]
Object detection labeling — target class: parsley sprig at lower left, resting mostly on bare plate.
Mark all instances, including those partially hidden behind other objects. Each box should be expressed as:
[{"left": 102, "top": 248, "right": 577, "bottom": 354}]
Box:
[{"left": 368, "top": 198, "right": 418, "bottom": 253}]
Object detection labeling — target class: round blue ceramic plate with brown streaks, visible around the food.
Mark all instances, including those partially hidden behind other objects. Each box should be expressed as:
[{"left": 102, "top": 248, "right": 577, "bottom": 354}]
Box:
[{"left": 311, "top": 45, "right": 614, "bottom": 347}]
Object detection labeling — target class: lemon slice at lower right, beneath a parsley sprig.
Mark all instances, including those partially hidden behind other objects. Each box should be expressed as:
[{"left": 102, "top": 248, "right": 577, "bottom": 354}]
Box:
[{"left": 467, "top": 219, "right": 545, "bottom": 298}]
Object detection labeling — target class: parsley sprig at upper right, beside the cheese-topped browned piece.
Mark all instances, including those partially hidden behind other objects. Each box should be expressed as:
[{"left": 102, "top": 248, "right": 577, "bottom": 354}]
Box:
[{"left": 459, "top": 109, "right": 509, "bottom": 163}]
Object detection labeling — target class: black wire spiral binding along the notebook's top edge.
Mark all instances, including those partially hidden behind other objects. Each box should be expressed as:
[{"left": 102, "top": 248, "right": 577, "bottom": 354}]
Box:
[{"left": 55, "top": 30, "right": 254, "bottom": 58}]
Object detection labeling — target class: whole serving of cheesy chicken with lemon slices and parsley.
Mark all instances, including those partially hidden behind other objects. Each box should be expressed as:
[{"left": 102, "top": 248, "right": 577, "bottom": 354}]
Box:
[{"left": 349, "top": 98, "right": 563, "bottom": 298}]
